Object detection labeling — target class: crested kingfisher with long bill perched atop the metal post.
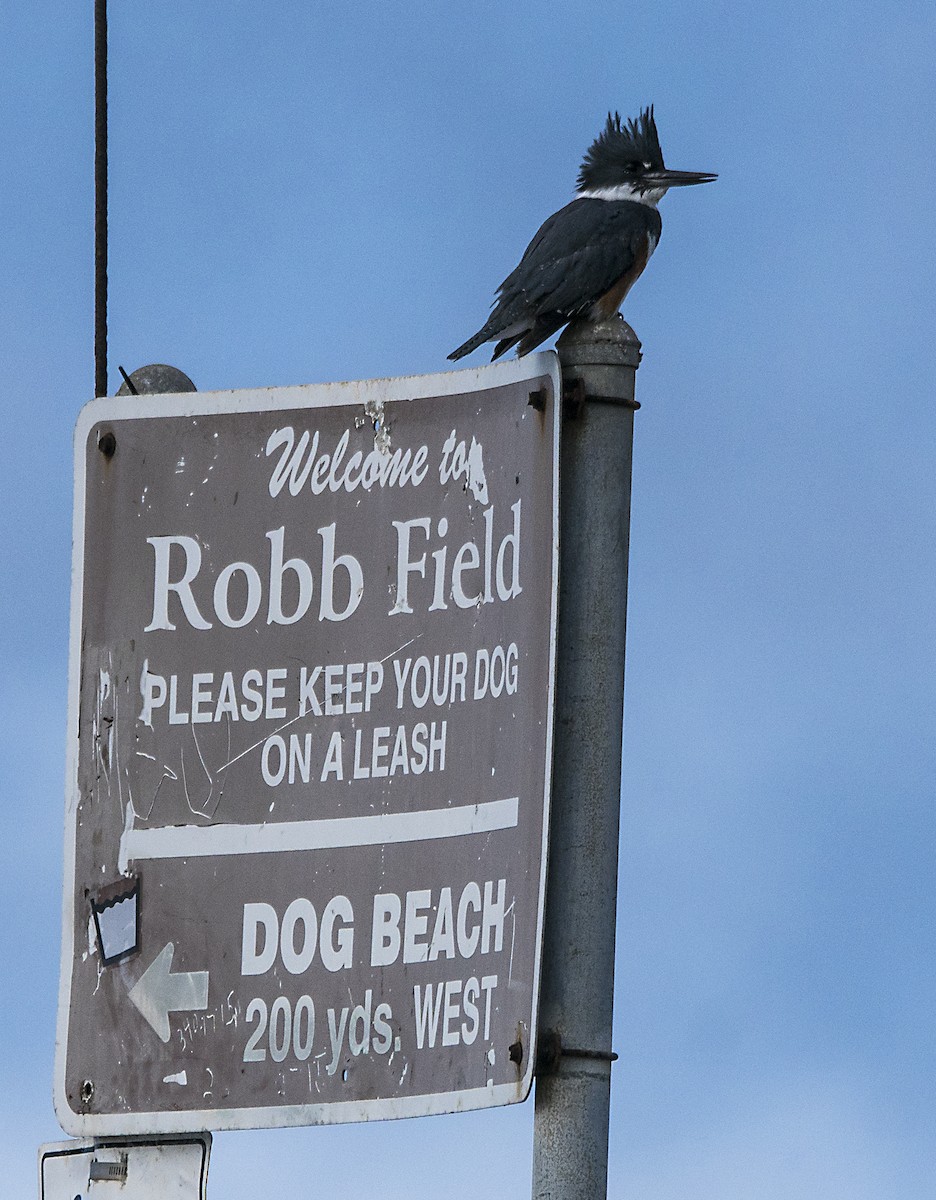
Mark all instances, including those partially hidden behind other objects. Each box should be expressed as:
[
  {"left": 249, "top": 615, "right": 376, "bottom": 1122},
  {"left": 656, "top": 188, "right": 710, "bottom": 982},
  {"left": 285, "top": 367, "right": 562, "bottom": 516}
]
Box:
[{"left": 449, "top": 106, "right": 718, "bottom": 361}]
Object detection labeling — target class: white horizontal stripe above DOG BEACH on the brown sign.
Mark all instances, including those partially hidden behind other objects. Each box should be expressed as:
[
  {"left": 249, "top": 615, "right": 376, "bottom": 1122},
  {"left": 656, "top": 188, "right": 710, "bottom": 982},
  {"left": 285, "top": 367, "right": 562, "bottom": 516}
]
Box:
[{"left": 120, "top": 796, "right": 520, "bottom": 863}]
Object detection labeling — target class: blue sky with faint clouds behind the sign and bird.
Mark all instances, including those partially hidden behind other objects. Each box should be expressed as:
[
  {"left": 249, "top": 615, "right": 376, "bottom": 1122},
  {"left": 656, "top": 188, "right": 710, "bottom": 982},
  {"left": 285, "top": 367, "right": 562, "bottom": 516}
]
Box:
[{"left": 0, "top": 0, "right": 936, "bottom": 1200}]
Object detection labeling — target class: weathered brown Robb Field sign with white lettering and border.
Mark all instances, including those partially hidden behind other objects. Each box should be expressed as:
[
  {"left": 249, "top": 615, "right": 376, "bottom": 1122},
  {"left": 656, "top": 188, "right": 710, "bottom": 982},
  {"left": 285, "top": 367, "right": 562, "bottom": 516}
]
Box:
[{"left": 55, "top": 354, "right": 560, "bottom": 1136}]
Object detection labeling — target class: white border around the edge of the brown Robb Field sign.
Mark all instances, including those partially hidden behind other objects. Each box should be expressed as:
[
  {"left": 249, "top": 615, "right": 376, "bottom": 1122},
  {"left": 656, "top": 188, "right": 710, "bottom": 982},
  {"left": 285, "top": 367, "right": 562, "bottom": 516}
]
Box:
[{"left": 53, "top": 350, "right": 562, "bottom": 1138}]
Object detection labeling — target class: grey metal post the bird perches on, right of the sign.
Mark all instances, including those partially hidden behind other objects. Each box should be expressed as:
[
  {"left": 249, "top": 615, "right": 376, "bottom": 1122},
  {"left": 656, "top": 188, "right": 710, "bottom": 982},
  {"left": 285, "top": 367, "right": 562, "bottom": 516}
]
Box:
[{"left": 533, "top": 317, "right": 640, "bottom": 1200}]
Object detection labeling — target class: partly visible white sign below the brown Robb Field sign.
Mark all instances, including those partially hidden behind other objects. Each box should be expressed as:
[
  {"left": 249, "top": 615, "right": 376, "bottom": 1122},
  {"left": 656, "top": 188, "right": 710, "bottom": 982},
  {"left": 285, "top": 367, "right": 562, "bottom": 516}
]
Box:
[{"left": 38, "top": 1133, "right": 211, "bottom": 1200}]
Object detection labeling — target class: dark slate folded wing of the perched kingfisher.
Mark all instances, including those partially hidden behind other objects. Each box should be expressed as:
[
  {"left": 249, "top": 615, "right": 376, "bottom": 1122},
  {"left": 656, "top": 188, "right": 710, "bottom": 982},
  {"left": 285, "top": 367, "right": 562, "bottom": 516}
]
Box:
[{"left": 492, "top": 198, "right": 660, "bottom": 329}]
